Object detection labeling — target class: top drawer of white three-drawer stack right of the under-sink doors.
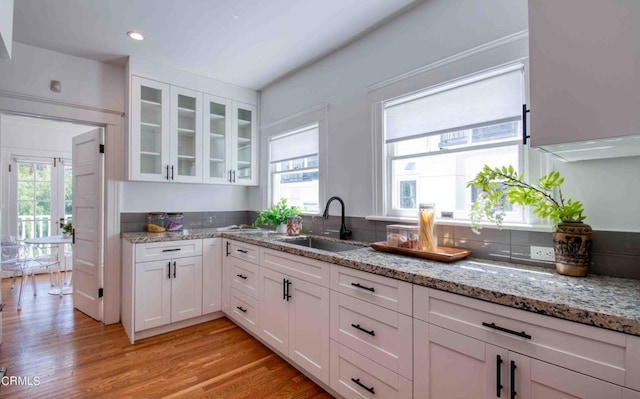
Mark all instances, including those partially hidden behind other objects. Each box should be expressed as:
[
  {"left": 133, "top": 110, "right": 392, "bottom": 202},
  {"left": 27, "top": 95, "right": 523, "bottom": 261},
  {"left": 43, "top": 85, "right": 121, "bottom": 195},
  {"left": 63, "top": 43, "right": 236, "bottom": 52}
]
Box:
[{"left": 331, "top": 266, "right": 413, "bottom": 316}]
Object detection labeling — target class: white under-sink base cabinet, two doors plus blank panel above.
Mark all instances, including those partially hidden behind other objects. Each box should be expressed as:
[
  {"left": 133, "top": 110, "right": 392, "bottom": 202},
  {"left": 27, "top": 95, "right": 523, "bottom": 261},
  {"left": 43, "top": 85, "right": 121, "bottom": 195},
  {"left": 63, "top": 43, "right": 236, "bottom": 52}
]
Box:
[{"left": 259, "top": 249, "right": 329, "bottom": 385}]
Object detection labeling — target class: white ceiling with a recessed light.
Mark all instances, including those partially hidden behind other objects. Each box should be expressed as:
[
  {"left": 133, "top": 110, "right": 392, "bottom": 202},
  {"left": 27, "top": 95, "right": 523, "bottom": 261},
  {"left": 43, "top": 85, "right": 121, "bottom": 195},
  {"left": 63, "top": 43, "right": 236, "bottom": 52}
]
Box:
[{"left": 13, "top": 0, "right": 420, "bottom": 89}]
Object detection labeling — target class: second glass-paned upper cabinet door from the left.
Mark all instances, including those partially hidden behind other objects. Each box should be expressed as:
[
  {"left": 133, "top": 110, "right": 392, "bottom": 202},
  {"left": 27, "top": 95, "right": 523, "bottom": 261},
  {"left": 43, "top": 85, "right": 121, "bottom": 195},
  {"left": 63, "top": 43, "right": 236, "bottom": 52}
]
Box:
[{"left": 169, "top": 86, "right": 202, "bottom": 183}]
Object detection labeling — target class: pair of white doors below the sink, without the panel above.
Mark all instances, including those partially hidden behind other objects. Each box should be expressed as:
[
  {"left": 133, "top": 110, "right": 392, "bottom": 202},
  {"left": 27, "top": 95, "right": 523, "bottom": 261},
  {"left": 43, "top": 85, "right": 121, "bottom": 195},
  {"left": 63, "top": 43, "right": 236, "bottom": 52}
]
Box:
[{"left": 259, "top": 267, "right": 329, "bottom": 384}]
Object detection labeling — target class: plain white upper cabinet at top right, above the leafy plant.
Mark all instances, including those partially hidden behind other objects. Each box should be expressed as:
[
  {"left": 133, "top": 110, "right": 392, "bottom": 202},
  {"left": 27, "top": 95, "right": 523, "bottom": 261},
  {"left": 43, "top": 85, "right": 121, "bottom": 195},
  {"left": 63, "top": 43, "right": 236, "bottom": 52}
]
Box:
[{"left": 529, "top": 0, "right": 640, "bottom": 152}]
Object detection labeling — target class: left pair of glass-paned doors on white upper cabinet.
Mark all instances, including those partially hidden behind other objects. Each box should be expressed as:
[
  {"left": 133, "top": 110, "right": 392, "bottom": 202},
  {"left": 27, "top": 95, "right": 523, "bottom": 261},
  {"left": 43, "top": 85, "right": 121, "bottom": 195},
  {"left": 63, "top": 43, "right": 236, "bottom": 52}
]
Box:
[{"left": 129, "top": 76, "right": 202, "bottom": 183}]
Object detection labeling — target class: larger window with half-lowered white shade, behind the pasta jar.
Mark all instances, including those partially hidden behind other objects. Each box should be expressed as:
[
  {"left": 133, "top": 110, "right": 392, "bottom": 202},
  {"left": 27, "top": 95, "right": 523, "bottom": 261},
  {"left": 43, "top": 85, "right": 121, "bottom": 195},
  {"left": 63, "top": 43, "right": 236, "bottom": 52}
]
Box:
[{"left": 382, "top": 64, "right": 524, "bottom": 222}]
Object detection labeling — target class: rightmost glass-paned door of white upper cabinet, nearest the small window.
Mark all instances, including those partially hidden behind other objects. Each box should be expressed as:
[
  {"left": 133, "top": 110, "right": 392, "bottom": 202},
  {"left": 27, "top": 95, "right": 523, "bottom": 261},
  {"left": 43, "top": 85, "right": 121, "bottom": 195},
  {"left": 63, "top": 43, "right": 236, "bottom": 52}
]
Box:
[{"left": 231, "top": 103, "right": 258, "bottom": 185}]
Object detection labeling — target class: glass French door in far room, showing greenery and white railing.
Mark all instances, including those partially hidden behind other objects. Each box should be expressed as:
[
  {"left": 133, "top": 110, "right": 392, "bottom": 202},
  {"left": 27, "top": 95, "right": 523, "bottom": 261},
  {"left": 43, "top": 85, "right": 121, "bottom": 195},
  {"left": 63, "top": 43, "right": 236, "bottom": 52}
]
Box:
[{"left": 10, "top": 158, "right": 72, "bottom": 240}]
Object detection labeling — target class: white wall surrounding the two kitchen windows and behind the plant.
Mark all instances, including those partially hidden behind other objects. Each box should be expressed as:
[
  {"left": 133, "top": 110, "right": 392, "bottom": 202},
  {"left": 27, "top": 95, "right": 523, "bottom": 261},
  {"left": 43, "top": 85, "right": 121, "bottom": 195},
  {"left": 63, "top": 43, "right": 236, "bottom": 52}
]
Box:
[{"left": 260, "top": 0, "right": 640, "bottom": 231}]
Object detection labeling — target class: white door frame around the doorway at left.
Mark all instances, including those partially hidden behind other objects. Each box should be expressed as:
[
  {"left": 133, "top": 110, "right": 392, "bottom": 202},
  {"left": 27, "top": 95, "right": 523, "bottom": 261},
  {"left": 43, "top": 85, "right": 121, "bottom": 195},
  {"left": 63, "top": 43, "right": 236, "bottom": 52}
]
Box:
[{"left": 0, "top": 95, "right": 126, "bottom": 324}]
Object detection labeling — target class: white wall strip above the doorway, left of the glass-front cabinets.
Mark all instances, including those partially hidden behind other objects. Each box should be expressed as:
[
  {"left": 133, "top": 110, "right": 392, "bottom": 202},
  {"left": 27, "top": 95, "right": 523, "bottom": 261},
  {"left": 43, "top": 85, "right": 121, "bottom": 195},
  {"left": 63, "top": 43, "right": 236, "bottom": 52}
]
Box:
[{"left": 0, "top": 42, "right": 125, "bottom": 112}]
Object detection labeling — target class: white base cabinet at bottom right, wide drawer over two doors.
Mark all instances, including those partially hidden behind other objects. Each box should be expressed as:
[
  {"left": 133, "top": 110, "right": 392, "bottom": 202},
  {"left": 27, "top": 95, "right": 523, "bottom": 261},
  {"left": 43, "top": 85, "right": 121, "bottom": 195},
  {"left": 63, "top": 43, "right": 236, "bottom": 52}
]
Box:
[{"left": 414, "top": 286, "right": 635, "bottom": 399}]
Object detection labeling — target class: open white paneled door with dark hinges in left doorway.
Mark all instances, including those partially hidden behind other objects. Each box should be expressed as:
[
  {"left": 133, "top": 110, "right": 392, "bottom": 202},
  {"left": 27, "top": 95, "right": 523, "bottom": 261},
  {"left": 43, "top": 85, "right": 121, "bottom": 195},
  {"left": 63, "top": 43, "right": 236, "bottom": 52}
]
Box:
[{"left": 72, "top": 128, "right": 103, "bottom": 320}]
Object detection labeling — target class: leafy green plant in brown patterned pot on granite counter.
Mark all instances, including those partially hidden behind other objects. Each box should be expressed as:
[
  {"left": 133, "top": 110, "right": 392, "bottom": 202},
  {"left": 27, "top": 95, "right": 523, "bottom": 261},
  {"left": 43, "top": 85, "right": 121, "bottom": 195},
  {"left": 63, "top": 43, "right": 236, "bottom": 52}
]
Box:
[{"left": 467, "top": 165, "right": 593, "bottom": 276}]
